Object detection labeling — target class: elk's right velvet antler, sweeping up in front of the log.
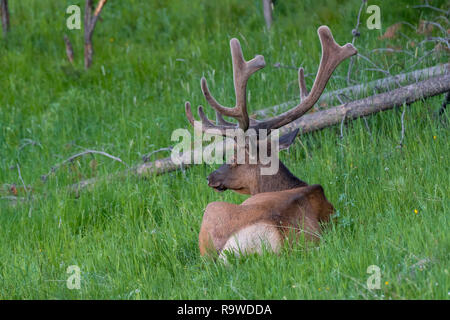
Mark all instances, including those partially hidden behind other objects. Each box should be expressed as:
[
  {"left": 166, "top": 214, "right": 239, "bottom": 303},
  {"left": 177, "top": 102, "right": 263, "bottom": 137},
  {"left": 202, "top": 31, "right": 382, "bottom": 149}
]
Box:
[{"left": 254, "top": 26, "right": 357, "bottom": 129}]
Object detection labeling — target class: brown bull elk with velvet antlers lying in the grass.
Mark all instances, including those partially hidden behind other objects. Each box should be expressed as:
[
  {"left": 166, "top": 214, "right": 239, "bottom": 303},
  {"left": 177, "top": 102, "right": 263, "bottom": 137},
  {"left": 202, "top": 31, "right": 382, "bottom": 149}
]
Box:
[{"left": 185, "top": 26, "right": 357, "bottom": 257}]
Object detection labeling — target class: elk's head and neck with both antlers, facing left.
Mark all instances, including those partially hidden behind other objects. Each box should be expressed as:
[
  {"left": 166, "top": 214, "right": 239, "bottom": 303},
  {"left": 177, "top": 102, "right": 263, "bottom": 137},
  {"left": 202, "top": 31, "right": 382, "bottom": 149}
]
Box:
[{"left": 185, "top": 26, "right": 357, "bottom": 195}]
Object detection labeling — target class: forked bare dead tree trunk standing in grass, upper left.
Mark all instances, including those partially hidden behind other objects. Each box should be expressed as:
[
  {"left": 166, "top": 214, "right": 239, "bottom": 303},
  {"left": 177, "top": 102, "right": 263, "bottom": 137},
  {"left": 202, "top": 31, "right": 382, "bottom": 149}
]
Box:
[{"left": 84, "top": 0, "right": 108, "bottom": 69}]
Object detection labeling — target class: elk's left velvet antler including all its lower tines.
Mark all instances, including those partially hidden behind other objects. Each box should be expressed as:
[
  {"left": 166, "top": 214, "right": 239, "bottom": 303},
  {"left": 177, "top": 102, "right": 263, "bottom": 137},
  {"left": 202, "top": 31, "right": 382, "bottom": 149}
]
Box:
[{"left": 186, "top": 38, "right": 266, "bottom": 134}]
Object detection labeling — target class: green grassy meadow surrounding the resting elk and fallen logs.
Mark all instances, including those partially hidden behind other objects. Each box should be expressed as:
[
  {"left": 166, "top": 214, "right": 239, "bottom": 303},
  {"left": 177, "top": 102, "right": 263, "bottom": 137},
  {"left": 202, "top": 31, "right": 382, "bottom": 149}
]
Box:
[{"left": 0, "top": 0, "right": 450, "bottom": 299}]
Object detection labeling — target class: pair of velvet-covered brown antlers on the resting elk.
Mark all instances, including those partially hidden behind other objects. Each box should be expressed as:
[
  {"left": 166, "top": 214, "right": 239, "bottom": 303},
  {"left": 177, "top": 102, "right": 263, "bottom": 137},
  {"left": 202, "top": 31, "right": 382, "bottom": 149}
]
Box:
[{"left": 185, "top": 26, "right": 357, "bottom": 136}]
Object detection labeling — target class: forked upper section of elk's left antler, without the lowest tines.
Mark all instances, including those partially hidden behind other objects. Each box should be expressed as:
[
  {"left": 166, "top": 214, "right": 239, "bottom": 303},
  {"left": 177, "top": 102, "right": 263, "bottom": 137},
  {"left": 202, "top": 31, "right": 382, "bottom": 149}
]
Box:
[{"left": 201, "top": 38, "right": 266, "bottom": 131}]
